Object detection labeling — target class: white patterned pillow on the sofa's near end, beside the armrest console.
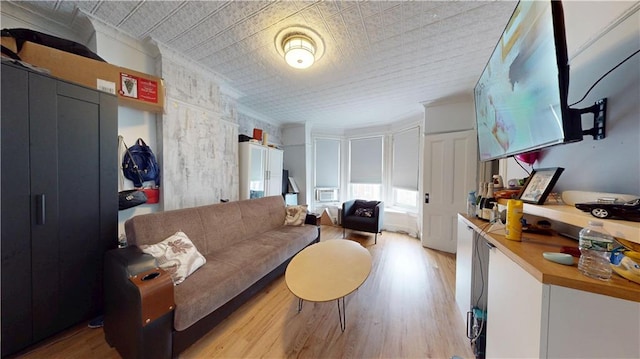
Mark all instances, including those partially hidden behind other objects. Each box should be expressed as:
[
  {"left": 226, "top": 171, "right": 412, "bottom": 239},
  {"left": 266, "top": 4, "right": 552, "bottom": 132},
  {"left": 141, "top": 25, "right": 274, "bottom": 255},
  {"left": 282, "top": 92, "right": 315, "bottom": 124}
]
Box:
[{"left": 140, "top": 232, "right": 207, "bottom": 285}]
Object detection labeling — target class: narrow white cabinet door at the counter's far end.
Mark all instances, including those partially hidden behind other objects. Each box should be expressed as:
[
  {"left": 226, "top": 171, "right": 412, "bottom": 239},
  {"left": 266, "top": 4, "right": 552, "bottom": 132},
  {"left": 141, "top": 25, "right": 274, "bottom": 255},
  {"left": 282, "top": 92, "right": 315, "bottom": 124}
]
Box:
[{"left": 456, "top": 219, "right": 474, "bottom": 323}]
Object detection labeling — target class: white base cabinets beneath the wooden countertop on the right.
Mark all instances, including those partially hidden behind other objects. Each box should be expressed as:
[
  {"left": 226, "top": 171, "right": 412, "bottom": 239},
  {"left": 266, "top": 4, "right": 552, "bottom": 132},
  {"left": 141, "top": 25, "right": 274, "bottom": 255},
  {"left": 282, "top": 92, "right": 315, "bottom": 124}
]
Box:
[{"left": 456, "top": 216, "right": 640, "bottom": 358}]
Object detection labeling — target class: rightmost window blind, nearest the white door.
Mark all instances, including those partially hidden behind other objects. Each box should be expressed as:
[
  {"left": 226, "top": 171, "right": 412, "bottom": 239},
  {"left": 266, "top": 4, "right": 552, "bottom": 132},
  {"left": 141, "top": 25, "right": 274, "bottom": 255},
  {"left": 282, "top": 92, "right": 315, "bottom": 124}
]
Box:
[{"left": 391, "top": 127, "right": 420, "bottom": 191}]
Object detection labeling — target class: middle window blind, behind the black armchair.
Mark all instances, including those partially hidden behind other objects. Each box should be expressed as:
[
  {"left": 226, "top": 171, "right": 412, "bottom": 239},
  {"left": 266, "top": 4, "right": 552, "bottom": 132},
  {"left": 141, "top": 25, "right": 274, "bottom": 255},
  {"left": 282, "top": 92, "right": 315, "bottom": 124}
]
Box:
[{"left": 349, "top": 136, "right": 382, "bottom": 184}]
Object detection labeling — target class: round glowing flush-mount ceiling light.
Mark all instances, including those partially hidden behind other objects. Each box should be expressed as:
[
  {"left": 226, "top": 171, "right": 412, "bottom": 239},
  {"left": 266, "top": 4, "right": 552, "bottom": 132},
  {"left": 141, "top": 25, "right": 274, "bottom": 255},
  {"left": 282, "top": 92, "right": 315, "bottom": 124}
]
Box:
[{"left": 275, "top": 26, "right": 324, "bottom": 69}]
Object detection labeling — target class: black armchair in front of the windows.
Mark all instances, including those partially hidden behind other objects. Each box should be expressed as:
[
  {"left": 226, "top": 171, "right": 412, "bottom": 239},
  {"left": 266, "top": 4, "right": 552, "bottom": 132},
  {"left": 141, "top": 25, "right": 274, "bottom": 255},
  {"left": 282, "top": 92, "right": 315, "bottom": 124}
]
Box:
[{"left": 341, "top": 199, "right": 384, "bottom": 244}]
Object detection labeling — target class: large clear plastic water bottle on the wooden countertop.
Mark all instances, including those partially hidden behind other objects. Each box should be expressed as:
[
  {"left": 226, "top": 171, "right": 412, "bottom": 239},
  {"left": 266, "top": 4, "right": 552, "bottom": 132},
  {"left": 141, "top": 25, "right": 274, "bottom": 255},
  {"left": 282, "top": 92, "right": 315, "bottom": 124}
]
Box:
[{"left": 578, "top": 221, "right": 614, "bottom": 280}]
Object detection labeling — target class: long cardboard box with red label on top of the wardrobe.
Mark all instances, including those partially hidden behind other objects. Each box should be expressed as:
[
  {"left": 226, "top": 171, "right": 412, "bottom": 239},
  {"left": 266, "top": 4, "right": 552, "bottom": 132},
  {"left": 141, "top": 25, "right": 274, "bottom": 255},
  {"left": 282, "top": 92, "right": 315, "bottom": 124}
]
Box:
[{"left": 13, "top": 42, "right": 164, "bottom": 112}]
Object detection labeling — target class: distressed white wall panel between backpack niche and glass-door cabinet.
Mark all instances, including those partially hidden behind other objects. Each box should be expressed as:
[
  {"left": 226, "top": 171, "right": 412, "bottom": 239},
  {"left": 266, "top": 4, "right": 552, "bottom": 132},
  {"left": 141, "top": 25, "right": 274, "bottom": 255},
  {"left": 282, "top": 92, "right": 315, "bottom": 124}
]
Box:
[{"left": 160, "top": 48, "right": 239, "bottom": 210}]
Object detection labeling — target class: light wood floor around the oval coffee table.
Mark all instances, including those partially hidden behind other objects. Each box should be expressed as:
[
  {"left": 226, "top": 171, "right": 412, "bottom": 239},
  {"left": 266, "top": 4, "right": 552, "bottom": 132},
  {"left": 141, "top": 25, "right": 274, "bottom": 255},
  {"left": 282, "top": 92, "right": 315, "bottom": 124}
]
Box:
[{"left": 15, "top": 226, "right": 473, "bottom": 358}]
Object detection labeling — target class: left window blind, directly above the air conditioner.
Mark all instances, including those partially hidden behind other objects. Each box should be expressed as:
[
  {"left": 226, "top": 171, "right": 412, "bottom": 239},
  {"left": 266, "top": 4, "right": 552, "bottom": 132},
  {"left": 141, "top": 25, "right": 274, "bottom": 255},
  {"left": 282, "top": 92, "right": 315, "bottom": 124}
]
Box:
[{"left": 315, "top": 139, "right": 340, "bottom": 188}]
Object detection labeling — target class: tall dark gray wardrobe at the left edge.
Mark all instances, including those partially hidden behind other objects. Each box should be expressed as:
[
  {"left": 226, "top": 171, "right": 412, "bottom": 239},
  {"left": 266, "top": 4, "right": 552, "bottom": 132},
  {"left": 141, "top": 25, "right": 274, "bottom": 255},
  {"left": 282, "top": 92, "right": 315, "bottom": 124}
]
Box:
[{"left": 0, "top": 63, "right": 118, "bottom": 356}]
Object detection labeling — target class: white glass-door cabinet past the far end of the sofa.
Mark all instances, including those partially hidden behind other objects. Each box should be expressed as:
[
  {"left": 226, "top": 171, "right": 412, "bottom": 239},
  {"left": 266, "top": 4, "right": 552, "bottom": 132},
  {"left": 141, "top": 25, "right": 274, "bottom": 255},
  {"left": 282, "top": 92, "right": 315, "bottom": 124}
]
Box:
[{"left": 239, "top": 142, "right": 284, "bottom": 199}]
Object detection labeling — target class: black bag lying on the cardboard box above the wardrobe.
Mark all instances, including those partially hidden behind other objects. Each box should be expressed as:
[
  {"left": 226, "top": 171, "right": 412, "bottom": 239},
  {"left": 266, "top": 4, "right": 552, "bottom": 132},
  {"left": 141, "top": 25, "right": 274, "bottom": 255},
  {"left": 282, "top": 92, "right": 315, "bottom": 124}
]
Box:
[{"left": 2, "top": 28, "right": 106, "bottom": 62}]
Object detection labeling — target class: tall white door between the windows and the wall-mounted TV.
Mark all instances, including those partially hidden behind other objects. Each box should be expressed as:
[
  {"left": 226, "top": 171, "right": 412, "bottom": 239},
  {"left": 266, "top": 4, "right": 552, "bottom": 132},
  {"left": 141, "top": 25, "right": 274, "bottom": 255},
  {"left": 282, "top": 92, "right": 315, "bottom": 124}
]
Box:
[{"left": 421, "top": 130, "right": 478, "bottom": 253}]
